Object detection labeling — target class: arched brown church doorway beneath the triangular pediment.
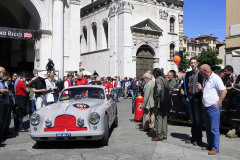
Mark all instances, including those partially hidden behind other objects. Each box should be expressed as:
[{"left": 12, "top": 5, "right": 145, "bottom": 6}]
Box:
[{"left": 136, "top": 45, "right": 155, "bottom": 78}]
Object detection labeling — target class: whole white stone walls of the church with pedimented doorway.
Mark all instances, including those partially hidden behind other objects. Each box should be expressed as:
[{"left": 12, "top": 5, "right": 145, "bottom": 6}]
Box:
[{"left": 81, "top": 0, "right": 183, "bottom": 77}]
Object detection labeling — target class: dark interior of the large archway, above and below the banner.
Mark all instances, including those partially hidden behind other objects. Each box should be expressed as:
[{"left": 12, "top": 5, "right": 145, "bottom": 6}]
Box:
[{"left": 0, "top": 0, "right": 41, "bottom": 73}]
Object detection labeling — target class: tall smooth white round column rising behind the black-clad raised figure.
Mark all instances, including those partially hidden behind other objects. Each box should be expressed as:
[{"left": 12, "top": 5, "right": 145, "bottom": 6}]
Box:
[{"left": 52, "top": 0, "right": 64, "bottom": 79}]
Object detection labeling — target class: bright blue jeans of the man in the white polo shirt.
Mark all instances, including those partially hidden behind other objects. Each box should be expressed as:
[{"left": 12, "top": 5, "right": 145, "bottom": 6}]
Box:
[{"left": 204, "top": 105, "right": 222, "bottom": 151}]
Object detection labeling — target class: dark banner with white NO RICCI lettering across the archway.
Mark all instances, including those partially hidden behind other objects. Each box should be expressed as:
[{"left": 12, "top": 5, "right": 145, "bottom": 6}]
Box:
[{"left": 0, "top": 27, "right": 34, "bottom": 41}]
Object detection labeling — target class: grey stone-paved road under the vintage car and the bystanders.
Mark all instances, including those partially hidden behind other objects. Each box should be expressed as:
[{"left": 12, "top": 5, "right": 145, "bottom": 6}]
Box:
[{"left": 0, "top": 99, "right": 240, "bottom": 160}]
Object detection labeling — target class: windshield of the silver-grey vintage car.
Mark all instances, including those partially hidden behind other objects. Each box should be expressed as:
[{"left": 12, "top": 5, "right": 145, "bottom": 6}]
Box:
[{"left": 59, "top": 87, "right": 105, "bottom": 101}]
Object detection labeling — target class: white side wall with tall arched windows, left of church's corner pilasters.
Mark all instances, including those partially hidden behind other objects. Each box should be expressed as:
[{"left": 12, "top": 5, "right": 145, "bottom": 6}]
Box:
[{"left": 80, "top": 6, "right": 111, "bottom": 76}]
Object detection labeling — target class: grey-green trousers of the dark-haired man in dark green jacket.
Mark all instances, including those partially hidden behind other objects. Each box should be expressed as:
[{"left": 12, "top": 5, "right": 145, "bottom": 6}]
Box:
[{"left": 155, "top": 112, "right": 168, "bottom": 138}]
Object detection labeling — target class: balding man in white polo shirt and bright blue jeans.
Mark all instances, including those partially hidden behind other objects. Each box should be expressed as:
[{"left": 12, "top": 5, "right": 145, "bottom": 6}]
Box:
[{"left": 197, "top": 64, "right": 227, "bottom": 155}]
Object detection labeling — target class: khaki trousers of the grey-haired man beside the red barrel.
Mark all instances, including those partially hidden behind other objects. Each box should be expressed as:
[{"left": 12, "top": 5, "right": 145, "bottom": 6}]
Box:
[{"left": 143, "top": 108, "right": 155, "bottom": 130}]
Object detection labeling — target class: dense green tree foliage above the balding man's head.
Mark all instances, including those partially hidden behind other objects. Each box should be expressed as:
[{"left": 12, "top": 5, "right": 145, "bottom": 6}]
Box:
[{"left": 197, "top": 48, "right": 223, "bottom": 72}]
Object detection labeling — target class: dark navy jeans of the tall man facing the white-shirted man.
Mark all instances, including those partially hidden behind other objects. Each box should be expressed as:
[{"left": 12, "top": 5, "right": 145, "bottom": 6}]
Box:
[{"left": 186, "top": 96, "right": 202, "bottom": 141}]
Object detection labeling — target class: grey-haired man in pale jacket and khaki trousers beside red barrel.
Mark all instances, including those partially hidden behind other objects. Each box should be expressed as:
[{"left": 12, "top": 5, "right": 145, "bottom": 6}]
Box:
[{"left": 140, "top": 73, "right": 155, "bottom": 131}]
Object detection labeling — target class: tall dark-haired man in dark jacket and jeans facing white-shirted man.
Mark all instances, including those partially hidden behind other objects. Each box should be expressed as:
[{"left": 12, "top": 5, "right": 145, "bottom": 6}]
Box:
[{"left": 181, "top": 57, "right": 203, "bottom": 146}]
